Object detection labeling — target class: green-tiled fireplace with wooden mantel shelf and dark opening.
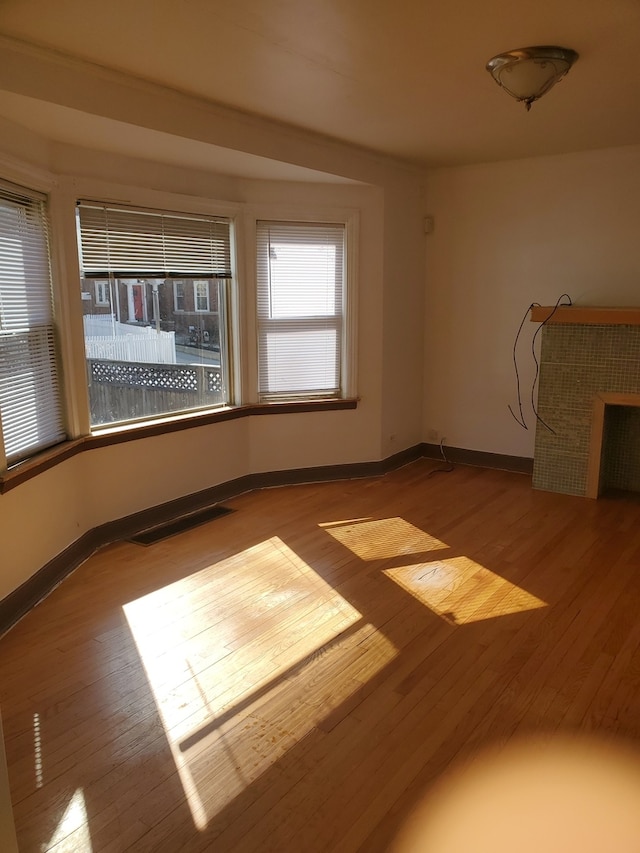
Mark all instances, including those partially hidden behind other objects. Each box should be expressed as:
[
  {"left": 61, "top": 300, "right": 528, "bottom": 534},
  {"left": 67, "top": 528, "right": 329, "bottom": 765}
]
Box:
[{"left": 531, "top": 307, "right": 640, "bottom": 497}]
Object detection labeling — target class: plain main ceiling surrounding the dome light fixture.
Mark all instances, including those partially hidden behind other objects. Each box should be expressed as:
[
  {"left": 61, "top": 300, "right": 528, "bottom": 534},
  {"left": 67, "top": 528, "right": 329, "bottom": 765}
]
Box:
[{"left": 0, "top": 0, "right": 640, "bottom": 171}]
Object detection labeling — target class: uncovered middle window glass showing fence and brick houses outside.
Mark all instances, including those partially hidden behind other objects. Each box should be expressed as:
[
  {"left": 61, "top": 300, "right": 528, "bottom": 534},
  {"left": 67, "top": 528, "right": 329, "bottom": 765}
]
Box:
[{"left": 83, "top": 278, "right": 228, "bottom": 426}]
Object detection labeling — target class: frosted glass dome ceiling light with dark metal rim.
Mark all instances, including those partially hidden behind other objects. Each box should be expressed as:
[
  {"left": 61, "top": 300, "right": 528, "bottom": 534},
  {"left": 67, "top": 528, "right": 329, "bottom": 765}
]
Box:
[{"left": 487, "top": 45, "right": 578, "bottom": 110}]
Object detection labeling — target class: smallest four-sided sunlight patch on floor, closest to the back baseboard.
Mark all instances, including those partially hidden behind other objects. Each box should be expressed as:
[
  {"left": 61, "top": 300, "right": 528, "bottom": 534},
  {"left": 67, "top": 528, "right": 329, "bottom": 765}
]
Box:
[{"left": 319, "top": 518, "right": 448, "bottom": 560}]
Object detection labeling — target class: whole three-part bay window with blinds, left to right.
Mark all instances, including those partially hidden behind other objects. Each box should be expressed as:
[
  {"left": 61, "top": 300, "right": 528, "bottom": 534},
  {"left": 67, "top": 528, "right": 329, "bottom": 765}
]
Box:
[{"left": 0, "top": 183, "right": 356, "bottom": 480}]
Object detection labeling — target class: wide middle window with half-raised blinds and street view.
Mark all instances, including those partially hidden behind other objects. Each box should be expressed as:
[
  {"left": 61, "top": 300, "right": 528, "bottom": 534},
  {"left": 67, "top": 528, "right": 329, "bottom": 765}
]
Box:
[{"left": 78, "top": 202, "right": 231, "bottom": 427}]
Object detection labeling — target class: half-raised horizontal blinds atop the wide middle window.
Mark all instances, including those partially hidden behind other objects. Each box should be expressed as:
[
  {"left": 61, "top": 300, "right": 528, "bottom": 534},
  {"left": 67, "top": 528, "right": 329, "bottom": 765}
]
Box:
[{"left": 79, "top": 202, "right": 231, "bottom": 278}]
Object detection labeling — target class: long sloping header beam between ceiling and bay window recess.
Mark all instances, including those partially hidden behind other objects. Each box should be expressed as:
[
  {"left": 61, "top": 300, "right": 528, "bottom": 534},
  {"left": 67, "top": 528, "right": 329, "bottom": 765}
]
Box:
[{"left": 0, "top": 35, "right": 426, "bottom": 184}]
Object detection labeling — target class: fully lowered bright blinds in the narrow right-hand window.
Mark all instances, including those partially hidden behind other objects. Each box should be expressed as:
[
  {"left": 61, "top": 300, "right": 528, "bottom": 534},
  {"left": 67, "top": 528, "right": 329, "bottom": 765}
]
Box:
[{"left": 257, "top": 222, "right": 345, "bottom": 400}]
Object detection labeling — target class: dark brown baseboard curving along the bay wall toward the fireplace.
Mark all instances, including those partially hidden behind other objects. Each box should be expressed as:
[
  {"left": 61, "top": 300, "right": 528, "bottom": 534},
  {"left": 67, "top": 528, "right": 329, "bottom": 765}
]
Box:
[{"left": 0, "top": 444, "right": 533, "bottom": 636}]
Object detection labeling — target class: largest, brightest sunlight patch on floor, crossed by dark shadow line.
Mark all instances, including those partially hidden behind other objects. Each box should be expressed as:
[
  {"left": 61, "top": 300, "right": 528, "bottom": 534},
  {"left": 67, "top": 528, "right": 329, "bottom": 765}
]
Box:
[{"left": 123, "top": 537, "right": 397, "bottom": 830}]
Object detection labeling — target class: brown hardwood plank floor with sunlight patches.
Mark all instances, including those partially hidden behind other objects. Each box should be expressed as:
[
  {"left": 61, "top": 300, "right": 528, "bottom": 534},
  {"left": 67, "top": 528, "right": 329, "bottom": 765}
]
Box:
[{"left": 0, "top": 460, "right": 640, "bottom": 853}]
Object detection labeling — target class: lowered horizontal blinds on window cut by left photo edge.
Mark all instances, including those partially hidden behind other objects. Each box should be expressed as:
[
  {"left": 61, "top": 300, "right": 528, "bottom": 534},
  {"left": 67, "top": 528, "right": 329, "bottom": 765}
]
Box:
[{"left": 0, "top": 185, "right": 65, "bottom": 464}]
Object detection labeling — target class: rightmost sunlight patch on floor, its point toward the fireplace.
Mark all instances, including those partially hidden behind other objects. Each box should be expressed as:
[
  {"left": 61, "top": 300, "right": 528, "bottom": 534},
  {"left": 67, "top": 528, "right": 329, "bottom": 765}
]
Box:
[{"left": 384, "top": 557, "right": 547, "bottom": 625}]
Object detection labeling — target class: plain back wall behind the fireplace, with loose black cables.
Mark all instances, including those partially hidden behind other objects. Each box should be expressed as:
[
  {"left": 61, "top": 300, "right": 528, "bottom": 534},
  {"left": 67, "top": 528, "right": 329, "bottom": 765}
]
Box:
[{"left": 423, "top": 147, "right": 640, "bottom": 456}]
